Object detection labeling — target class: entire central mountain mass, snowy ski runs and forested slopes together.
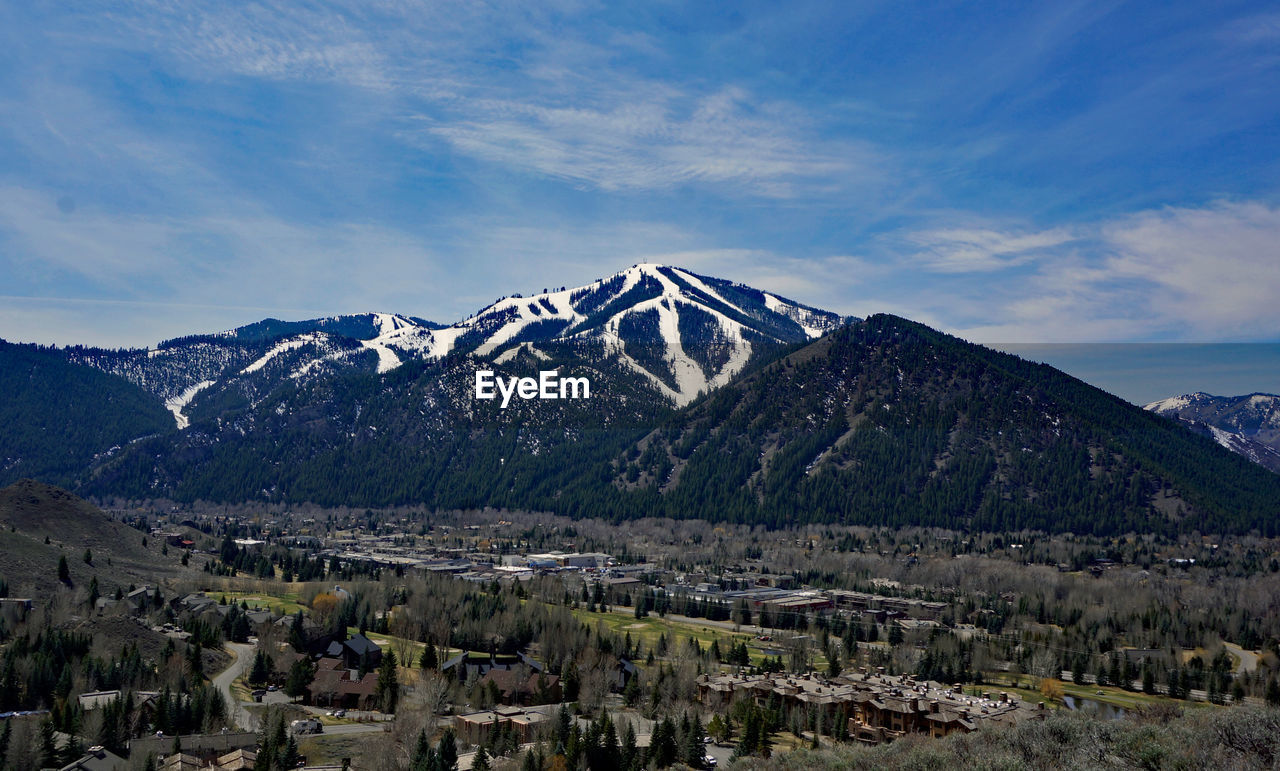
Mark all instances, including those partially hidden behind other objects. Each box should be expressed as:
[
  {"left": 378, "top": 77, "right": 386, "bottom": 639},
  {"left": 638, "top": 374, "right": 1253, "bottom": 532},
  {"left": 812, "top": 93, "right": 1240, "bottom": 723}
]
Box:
[{"left": 0, "top": 265, "right": 1280, "bottom": 533}]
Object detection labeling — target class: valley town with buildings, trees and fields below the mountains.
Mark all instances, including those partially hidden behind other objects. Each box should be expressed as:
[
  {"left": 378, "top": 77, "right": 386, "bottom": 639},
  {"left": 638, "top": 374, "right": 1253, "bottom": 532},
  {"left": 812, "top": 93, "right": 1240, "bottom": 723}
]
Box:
[{"left": 4, "top": 491, "right": 1280, "bottom": 770}]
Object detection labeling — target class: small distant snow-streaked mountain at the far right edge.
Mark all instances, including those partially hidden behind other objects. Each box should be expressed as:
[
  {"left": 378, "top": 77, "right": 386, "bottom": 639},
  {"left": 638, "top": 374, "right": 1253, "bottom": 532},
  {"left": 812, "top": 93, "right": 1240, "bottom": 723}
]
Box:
[{"left": 1146, "top": 392, "right": 1280, "bottom": 473}]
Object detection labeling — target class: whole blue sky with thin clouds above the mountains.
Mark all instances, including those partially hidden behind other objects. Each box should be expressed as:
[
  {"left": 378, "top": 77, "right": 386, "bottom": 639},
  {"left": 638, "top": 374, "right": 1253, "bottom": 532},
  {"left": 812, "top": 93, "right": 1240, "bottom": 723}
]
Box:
[{"left": 0, "top": 0, "right": 1280, "bottom": 346}]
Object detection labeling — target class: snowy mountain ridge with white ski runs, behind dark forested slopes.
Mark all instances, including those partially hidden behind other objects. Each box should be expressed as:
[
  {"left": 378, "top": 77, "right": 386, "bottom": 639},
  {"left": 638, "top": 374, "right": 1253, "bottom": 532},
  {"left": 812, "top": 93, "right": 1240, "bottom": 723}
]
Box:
[{"left": 69, "top": 264, "right": 845, "bottom": 429}]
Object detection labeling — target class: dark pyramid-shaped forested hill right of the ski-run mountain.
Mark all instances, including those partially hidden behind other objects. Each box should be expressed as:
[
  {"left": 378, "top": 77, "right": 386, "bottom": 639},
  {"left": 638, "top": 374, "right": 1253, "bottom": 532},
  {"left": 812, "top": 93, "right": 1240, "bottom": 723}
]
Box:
[{"left": 607, "top": 315, "right": 1280, "bottom": 534}]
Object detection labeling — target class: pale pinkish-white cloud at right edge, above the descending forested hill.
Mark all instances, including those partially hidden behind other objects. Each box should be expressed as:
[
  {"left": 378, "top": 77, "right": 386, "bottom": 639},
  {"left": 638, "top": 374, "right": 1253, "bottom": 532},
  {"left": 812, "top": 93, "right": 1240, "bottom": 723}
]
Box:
[{"left": 940, "top": 201, "right": 1280, "bottom": 342}]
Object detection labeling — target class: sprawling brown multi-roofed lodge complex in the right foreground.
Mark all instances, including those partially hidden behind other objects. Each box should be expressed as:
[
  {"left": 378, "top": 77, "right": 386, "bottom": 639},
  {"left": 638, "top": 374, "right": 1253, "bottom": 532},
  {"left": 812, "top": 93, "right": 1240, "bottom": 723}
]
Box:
[{"left": 698, "top": 667, "right": 1046, "bottom": 744}]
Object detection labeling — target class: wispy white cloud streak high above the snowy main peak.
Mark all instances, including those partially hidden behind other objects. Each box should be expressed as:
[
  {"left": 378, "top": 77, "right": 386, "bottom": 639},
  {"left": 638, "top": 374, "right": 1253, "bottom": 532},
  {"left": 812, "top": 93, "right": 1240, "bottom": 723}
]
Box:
[{"left": 424, "top": 88, "right": 874, "bottom": 197}]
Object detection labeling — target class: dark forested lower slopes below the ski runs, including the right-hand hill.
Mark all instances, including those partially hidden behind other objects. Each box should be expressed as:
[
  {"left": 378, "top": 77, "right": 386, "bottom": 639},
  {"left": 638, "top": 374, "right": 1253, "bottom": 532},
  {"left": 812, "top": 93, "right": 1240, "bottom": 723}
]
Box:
[{"left": 72, "top": 315, "right": 1280, "bottom": 534}]
